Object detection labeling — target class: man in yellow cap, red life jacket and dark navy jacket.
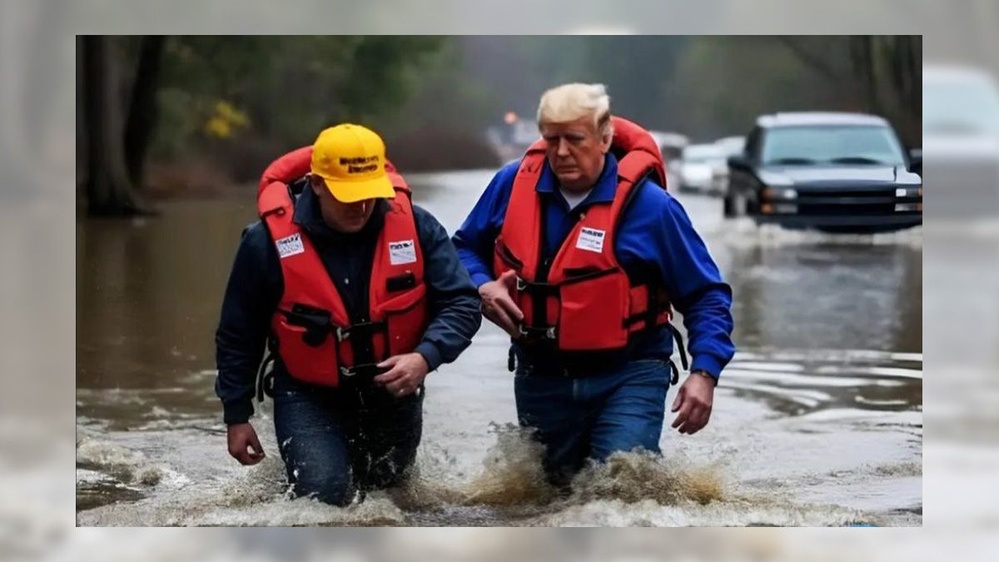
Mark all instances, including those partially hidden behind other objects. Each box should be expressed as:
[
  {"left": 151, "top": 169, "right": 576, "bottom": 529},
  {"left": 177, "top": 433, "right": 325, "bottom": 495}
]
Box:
[{"left": 215, "top": 124, "right": 481, "bottom": 506}]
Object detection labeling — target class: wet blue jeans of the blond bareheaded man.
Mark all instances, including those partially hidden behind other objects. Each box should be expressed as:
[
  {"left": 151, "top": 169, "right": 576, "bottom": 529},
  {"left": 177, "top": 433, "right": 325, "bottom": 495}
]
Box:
[{"left": 514, "top": 360, "right": 672, "bottom": 485}]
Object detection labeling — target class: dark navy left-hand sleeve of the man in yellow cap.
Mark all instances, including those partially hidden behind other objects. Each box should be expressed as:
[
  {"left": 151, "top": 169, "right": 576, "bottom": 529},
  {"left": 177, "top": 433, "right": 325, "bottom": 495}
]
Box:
[{"left": 215, "top": 223, "right": 282, "bottom": 425}]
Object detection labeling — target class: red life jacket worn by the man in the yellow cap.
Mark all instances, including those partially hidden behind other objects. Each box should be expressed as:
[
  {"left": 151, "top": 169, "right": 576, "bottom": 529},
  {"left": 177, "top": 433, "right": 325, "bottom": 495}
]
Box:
[{"left": 257, "top": 146, "right": 429, "bottom": 386}]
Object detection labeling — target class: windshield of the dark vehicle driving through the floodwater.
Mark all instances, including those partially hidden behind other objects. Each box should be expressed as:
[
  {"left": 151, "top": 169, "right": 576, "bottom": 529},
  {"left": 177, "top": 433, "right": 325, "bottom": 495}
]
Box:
[{"left": 762, "top": 125, "right": 905, "bottom": 166}]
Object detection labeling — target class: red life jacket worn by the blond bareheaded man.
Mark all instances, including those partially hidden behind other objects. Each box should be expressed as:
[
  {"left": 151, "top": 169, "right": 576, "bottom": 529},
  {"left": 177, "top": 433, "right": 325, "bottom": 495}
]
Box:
[{"left": 493, "top": 117, "right": 672, "bottom": 352}]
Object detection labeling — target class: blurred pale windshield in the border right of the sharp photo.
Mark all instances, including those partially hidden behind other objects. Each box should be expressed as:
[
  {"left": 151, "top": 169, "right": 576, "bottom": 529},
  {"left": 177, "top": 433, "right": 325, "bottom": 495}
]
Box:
[{"left": 923, "top": 73, "right": 999, "bottom": 134}]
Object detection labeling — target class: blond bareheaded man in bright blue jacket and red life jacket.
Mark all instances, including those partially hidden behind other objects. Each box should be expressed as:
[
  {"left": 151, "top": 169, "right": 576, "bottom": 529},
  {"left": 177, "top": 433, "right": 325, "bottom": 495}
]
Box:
[{"left": 453, "top": 84, "right": 735, "bottom": 484}]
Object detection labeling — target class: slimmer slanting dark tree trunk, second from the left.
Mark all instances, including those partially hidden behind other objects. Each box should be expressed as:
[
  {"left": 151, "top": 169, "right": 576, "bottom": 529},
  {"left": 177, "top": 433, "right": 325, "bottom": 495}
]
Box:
[{"left": 125, "top": 35, "right": 166, "bottom": 189}]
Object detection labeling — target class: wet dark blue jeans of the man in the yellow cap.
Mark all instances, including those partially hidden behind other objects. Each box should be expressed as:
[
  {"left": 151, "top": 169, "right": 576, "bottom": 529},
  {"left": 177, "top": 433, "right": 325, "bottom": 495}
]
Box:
[{"left": 274, "top": 377, "right": 424, "bottom": 506}]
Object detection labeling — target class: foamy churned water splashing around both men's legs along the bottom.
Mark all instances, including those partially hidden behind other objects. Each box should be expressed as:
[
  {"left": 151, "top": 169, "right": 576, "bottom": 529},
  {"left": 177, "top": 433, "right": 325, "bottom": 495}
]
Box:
[{"left": 78, "top": 416, "right": 904, "bottom": 527}]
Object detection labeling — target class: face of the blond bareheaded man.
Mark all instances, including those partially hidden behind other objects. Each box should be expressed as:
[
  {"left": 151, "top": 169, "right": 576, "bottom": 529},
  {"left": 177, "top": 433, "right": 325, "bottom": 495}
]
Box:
[{"left": 541, "top": 116, "right": 611, "bottom": 192}]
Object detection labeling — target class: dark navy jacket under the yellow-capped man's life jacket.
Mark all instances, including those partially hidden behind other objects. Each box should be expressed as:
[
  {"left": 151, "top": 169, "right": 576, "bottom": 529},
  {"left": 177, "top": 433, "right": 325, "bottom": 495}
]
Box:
[{"left": 215, "top": 182, "right": 482, "bottom": 424}]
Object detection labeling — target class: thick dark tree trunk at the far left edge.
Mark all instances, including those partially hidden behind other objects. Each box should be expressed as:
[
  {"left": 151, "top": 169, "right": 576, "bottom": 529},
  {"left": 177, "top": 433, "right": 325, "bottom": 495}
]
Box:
[{"left": 82, "top": 35, "right": 139, "bottom": 217}]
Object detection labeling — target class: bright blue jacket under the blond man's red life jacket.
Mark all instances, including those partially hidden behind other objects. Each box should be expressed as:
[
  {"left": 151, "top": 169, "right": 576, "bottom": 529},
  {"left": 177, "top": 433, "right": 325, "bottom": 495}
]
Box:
[{"left": 453, "top": 154, "right": 735, "bottom": 379}]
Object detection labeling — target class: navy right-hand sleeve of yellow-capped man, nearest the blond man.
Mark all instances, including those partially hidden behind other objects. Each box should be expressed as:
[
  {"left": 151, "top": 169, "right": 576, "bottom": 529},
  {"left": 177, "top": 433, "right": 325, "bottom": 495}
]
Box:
[{"left": 413, "top": 203, "right": 482, "bottom": 371}]
